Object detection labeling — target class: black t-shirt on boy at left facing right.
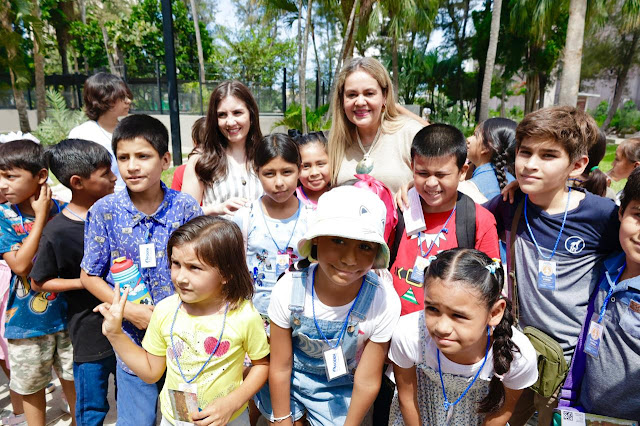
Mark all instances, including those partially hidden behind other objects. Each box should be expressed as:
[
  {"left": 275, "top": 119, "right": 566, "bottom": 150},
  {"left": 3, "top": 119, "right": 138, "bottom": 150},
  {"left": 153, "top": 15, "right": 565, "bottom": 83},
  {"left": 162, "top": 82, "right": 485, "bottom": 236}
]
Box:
[{"left": 30, "top": 214, "right": 113, "bottom": 362}]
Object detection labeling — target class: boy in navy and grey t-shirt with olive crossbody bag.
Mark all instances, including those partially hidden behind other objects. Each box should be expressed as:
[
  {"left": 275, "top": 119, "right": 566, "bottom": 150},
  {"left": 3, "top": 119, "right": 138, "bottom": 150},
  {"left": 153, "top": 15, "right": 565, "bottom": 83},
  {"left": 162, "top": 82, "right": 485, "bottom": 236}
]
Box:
[{"left": 487, "top": 107, "right": 619, "bottom": 425}]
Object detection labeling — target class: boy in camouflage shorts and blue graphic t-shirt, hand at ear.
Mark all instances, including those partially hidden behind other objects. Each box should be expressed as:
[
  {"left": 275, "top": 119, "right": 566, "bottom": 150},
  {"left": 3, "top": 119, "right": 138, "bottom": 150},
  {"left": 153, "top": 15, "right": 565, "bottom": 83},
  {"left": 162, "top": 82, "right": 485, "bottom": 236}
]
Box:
[{"left": 0, "top": 139, "right": 75, "bottom": 426}]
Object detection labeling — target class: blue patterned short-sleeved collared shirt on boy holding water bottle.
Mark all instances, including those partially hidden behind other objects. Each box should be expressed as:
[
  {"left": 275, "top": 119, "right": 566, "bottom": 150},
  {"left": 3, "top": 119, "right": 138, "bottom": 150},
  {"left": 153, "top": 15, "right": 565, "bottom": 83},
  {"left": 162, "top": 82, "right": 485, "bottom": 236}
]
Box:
[{"left": 80, "top": 183, "right": 202, "bottom": 371}]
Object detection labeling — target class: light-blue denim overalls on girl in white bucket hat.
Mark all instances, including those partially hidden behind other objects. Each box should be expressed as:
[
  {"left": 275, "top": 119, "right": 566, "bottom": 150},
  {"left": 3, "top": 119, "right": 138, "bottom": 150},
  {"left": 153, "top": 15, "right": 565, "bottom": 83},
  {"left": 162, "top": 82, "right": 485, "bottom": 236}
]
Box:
[{"left": 256, "top": 266, "right": 380, "bottom": 426}]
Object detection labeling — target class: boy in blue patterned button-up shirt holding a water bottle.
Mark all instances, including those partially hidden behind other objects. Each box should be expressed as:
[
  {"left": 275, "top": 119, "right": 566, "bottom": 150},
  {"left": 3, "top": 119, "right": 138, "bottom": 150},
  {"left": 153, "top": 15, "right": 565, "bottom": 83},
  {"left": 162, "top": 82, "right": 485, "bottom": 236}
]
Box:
[{"left": 80, "top": 115, "right": 202, "bottom": 426}]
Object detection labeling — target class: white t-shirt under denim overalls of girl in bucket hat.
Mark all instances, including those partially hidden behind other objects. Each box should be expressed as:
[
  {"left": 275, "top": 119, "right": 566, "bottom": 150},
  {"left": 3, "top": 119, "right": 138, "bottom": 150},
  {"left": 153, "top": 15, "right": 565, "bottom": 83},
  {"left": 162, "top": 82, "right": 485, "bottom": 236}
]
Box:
[{"left": 269, "top": 264, "right": 400, "bottom": 353}]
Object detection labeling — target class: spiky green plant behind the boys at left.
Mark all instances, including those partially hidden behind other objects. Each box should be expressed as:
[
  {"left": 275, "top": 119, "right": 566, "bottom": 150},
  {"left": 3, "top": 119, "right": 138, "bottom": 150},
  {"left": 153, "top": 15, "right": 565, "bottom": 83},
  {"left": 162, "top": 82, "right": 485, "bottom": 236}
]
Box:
[{"left": 33, "top": 89, "right": 87, "bottom": 145}]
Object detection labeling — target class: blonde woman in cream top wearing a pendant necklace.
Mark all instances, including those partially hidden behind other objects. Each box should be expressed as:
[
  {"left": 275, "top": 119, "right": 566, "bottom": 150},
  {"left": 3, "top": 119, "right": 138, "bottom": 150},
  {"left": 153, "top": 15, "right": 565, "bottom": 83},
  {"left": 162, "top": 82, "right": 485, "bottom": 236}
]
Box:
[{"left": 329, "top": 58, "right": 423, "bottom": 193}]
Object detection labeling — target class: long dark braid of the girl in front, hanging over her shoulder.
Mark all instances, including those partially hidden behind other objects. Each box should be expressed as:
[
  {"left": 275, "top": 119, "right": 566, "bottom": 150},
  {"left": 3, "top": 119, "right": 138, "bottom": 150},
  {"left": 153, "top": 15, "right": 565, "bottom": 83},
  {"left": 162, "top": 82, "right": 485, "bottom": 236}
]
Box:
[{"left": 478, "top": 299, "right": 519, "bottom": 414}]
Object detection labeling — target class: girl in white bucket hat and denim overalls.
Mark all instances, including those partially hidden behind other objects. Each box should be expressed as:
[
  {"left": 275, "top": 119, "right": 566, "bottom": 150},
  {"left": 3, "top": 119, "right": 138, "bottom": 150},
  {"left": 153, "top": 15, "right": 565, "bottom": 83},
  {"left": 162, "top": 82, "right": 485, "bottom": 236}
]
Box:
[{"left": 256, "top": 186, "right": 400, "bottom": 425}]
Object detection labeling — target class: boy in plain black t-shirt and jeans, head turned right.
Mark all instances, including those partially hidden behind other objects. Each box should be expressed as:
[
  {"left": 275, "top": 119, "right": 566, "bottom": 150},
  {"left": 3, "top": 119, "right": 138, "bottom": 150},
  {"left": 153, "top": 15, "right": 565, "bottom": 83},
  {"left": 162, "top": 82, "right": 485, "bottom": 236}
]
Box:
[{"left": 30, "top": 139, "right": 116, "bottom": 425}]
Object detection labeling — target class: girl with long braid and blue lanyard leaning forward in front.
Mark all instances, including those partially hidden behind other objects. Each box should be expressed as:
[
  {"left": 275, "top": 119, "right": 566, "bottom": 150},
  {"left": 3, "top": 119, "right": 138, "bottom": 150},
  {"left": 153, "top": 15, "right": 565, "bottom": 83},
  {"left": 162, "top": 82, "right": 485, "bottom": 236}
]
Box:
[{"left": 389, "top": 248, "right": 538, "bottom": 426}]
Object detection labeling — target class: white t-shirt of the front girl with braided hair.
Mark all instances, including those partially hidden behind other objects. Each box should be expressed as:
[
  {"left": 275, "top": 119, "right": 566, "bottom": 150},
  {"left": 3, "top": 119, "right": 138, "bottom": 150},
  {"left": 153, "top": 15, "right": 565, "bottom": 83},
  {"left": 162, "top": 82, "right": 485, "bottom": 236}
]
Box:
[{"left": 389, "top": 311, "right": 538, "bottom": 389}]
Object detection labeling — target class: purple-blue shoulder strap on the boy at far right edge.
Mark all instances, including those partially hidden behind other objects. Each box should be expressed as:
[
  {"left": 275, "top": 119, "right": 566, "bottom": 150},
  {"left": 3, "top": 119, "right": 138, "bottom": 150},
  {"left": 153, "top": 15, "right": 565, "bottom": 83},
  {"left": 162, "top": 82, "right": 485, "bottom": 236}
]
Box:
[{"left": 558, "top": 280, "right": 606, "bottom": 407}]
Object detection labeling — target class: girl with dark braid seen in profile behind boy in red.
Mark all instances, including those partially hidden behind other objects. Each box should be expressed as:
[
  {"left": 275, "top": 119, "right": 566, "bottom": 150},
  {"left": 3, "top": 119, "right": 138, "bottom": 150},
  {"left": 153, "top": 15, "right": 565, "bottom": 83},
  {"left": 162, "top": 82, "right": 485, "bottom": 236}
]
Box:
[{"left": 467, "top": 118, "right": 517, "bottom": 200}]
